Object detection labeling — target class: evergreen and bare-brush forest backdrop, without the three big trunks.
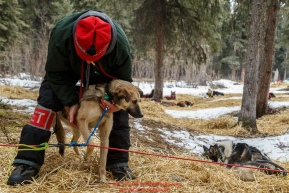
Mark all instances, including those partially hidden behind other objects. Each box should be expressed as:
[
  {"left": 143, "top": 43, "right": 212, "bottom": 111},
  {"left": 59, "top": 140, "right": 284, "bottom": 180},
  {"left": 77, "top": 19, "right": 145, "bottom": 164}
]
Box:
[{"left": 0, "top": 0, "right": 289, "bottom": 84}]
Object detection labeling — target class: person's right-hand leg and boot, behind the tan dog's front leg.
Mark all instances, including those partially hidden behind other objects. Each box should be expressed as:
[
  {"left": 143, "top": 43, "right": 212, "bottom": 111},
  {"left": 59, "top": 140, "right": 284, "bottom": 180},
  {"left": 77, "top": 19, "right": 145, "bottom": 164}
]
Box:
[{"left": 106, "top": 110, "right": 135, "bottom": 180}]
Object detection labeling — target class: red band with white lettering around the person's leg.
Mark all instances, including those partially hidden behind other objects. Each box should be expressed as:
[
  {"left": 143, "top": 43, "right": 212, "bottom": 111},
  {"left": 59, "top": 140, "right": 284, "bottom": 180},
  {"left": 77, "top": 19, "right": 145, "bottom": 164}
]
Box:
[{"left": 28, "top": 105, "right": 56, "bottom": 131}]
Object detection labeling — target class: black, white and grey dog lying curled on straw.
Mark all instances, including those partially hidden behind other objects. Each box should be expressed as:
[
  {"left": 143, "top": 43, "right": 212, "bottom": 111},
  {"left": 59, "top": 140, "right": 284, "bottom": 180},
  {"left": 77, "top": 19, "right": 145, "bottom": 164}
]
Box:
[{"left": 203, "top": 140, "right": 286, "bottom": 181}]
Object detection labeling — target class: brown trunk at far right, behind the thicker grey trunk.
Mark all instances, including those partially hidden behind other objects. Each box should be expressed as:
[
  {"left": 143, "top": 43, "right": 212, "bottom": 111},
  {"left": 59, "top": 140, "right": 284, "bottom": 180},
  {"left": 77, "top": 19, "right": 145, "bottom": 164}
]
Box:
[{"left": 256, "top": 0, "right": 280, "bottom": 118}]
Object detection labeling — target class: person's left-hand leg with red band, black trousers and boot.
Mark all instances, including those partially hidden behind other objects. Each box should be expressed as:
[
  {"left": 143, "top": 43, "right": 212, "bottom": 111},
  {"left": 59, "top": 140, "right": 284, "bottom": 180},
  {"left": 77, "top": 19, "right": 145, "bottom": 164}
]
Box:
[{"left": 7, "top": 77, "right": 63, "bottom": 185}]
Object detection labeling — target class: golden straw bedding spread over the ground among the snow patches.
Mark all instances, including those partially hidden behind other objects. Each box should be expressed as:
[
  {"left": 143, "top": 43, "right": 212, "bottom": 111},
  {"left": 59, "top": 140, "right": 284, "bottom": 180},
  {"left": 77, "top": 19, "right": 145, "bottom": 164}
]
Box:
[{"left": 0, "top": 85, "right": 289, "bottom": 193}]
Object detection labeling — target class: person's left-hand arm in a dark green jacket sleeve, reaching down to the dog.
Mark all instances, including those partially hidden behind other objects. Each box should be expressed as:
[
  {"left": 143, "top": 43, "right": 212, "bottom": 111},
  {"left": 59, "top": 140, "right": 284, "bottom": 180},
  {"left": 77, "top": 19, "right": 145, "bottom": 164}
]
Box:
[{"left": 45, "top": 30, "right": 81, "bottom": 107}]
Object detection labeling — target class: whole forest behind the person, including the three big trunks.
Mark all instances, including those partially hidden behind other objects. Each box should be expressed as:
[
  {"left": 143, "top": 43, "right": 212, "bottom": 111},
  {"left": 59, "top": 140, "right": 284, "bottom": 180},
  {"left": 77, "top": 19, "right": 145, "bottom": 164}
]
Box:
[{"left": 0, "top": 0, "right": 289, "bottom": 133}]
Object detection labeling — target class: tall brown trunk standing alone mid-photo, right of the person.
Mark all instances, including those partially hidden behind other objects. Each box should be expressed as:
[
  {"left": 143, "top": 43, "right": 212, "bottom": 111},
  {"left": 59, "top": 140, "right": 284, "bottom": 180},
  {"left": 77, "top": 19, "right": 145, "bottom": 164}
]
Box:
[{"left": 153, "top": 0, "right": 165, "bottom": 99}]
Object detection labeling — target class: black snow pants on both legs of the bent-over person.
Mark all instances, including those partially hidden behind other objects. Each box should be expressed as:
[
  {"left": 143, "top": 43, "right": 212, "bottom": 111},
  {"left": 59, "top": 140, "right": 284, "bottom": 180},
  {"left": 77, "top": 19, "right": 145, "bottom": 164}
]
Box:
[{"left": 13, "top": 77, "right": 130, "bottom": 170}]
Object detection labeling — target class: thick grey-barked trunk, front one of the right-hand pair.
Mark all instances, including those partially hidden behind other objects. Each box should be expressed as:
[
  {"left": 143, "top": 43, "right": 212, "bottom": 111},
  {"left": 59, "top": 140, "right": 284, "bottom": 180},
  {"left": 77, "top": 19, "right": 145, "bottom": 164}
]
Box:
[{"left": 238, "top": 0, "right": 264, "bottom": 133}]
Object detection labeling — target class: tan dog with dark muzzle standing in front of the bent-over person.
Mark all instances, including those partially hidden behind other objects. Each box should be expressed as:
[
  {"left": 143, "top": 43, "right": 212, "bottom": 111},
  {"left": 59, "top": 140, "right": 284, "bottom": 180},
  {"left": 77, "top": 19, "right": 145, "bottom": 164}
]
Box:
[{"left": 54, "top": 80, "right": 143, "bottom": 182}]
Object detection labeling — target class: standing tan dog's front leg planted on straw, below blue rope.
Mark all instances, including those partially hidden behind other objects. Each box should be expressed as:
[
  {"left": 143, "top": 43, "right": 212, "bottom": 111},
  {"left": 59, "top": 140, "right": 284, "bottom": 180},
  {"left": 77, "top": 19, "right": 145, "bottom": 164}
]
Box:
[{"left": 99, "top": 119, "right": 112, "bottom": 183}]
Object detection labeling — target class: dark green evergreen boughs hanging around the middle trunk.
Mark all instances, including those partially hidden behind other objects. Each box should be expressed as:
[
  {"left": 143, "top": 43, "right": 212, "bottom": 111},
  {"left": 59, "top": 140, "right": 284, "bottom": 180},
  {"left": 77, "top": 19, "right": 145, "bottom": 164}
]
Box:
[{"left": 133, "top": 0, "right": 220, "bottom": 64}]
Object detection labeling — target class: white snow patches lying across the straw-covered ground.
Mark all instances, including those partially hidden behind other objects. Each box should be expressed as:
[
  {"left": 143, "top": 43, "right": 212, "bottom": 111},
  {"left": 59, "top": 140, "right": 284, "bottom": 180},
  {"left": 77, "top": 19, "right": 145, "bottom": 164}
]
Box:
[{"left": 0, "top": 74, "right": 289, "bottom": 161}]
